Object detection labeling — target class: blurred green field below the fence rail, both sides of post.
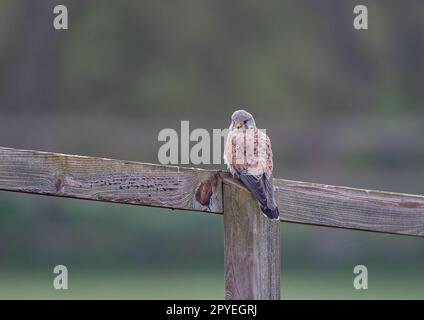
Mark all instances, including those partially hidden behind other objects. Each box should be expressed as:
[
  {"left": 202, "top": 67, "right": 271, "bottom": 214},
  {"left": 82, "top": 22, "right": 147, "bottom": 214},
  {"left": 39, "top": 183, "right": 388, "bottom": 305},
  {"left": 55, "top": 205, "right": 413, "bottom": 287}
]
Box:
[{"left": 0, "top": 193, "right": 424, "bottom": 299}]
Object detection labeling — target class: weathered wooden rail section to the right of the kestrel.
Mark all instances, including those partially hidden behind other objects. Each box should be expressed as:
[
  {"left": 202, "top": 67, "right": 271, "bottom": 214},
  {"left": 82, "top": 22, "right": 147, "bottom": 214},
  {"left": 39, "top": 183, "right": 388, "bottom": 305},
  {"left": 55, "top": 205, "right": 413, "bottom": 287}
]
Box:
[{"left": 274, "top": 179, "right": 424, "bottom": 236}]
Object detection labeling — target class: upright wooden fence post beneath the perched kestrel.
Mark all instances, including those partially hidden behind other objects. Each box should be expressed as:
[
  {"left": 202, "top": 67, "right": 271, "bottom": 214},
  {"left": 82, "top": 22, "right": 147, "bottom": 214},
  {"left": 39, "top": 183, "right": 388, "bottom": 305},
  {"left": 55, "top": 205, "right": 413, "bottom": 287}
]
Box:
[{"left": 223, "top": 180, "right": 280, "bottom": 300}]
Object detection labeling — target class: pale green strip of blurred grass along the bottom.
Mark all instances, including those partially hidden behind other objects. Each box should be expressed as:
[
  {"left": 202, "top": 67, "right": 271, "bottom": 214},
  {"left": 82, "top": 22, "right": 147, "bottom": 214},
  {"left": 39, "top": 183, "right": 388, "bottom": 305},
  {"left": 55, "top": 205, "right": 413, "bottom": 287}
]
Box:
[{"left": 0, "top": 271, "right": 424, "bottom": 299}]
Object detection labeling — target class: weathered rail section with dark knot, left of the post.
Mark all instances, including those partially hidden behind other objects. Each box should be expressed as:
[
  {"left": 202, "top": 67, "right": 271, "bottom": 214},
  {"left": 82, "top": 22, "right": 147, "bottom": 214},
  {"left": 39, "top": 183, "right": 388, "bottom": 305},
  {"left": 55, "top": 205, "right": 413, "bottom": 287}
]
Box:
[{"left": 0, "top": 148, "right": 222, "bottom": 212}]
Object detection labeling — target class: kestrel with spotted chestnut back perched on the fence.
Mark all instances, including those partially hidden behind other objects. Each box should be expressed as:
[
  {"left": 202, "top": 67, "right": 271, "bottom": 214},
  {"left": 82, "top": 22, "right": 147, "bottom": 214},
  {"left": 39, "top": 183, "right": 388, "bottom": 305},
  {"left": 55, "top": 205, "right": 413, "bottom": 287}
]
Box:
[{"left": 224, "top": 110, "right": 280, "bottom": 219}]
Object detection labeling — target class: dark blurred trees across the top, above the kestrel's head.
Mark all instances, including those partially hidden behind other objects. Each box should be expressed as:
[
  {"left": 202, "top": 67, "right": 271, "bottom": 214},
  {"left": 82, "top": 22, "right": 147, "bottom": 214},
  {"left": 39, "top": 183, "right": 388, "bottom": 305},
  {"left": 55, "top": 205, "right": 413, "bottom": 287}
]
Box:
[{"left": 0, "top": 0, "right": 424, "bottom": 116}]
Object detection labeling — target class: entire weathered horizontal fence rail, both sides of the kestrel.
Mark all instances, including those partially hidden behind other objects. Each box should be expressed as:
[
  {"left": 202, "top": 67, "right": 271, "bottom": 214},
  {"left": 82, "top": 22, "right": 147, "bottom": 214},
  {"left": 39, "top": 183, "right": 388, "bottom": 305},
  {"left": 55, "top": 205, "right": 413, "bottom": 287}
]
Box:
[{"left": 0, "top": 148, "right": 424, "bottom": 236}]
